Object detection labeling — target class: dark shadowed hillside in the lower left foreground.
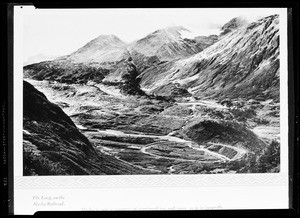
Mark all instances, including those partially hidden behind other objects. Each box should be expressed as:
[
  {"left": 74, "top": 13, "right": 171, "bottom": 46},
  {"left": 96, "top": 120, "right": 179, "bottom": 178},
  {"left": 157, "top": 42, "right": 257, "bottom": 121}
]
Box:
[{"left": 23, "top": 81, "right": 149, "bottom": 176}]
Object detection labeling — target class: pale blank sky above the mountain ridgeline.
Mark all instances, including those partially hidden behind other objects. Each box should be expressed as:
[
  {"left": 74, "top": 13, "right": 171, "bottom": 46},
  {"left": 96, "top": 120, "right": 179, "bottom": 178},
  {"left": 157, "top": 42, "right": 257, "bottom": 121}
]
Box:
[{"left": 15, "top": 6, "right": 277, "bottom": 61}]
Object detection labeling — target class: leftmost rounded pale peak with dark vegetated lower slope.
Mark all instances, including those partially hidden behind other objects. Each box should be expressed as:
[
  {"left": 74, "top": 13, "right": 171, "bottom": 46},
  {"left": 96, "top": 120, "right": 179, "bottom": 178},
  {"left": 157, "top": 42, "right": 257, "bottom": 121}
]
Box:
[{"left": 24, "top": 35, "right": 130, "bottom": 83}]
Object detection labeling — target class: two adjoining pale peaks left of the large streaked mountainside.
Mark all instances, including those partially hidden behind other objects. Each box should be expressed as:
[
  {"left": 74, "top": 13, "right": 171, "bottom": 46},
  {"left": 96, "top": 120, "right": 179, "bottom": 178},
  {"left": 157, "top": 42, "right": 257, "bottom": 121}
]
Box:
[{"left": 24, "top": 26, "right": 215, "bottom": 83}]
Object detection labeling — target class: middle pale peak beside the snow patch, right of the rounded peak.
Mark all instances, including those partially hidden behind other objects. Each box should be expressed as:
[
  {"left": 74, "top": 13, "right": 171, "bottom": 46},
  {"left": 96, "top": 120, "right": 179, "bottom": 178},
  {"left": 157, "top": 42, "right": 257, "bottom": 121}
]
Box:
[{"left": 128, "top": 26, "right": 214, "bottom": 71}]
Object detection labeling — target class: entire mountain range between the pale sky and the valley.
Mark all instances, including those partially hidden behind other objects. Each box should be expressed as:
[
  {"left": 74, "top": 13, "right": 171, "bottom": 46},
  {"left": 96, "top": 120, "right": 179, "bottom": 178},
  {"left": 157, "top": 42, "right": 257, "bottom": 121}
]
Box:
[{"left": 24, "top": 15, "right": 279, "bottom": 100}]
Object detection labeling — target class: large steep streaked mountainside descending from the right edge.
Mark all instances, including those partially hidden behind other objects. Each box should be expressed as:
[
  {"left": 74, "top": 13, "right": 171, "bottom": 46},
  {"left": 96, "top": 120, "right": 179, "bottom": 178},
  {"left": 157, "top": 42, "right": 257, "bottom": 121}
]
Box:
[{"left": 140, "top": 15, "right": 279, "bottom": 100}]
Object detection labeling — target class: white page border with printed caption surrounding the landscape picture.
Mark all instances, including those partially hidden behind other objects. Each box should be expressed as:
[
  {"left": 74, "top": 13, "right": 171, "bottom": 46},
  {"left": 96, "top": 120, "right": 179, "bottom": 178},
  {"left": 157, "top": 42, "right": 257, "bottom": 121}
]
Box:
[{"left": 13, "top": 6, "right": 289, "bottom": 214}]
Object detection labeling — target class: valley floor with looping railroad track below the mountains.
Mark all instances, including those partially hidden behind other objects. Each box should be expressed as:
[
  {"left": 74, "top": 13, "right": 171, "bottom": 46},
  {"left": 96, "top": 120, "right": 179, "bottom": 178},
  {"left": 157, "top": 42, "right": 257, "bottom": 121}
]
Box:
[{"left": 24, "top": 79, "right": 279, "bottom": 174}]
